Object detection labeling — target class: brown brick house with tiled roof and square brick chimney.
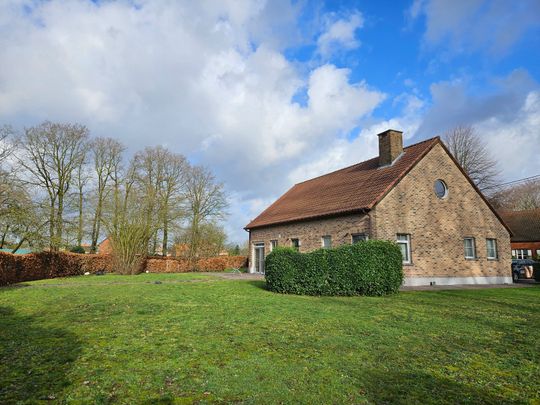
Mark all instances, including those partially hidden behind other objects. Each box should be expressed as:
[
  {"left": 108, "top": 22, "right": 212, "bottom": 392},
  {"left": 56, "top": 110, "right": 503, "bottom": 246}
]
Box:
[{"left": 245, "top": 130, "right": 512, "bottom": 285}]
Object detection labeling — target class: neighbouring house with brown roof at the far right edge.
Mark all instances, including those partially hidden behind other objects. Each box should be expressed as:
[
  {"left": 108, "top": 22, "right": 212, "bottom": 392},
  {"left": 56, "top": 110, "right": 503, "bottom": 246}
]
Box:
[{"left": 499, "top": 208, "right": 540, "bottom": 259}]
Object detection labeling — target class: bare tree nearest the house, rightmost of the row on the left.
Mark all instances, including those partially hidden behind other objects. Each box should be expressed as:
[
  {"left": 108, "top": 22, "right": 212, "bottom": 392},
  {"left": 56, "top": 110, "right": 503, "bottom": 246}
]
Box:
[{"left": 186, "top": 166, "right": 228, "bottom": 262}]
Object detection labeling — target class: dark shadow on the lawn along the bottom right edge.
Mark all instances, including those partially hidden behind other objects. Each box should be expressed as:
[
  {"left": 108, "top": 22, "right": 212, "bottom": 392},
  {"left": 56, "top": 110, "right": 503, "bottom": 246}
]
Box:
[{"left": 358, "top": 370, "right": 521, "bottom": 404}]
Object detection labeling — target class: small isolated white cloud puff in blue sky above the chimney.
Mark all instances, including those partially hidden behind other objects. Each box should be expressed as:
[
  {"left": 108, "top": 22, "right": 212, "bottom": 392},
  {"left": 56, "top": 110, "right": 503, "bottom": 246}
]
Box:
[{"left": 317, "top": 11, "right": 364, "bottom": 57}]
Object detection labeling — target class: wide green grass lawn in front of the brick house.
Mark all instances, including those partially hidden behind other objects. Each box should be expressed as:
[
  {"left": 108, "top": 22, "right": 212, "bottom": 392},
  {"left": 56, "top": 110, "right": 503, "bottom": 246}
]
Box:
[{"left": 0, "top": 274, "right": 540, "bottom": 404}]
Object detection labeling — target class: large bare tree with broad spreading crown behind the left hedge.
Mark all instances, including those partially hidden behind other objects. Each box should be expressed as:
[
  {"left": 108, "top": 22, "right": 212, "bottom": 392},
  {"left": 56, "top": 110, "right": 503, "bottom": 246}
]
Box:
[{"left": 18, "top": 121, "right": 88, "bottom": 250}]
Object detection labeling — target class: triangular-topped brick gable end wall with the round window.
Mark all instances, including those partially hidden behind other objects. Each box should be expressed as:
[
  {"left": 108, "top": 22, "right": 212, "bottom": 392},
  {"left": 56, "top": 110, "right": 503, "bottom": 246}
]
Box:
[{"left": 371, "top": 145, "right": 511, "bottom": 277}]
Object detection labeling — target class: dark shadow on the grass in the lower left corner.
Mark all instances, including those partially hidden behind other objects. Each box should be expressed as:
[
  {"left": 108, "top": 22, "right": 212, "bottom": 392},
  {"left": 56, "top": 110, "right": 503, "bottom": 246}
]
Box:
[{"left": 0, "top": 307, "right": 81, "bottom": 403}]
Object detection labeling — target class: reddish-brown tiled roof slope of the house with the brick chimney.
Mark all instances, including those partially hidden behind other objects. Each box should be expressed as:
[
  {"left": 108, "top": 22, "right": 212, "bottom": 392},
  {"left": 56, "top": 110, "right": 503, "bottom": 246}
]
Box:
[{"left": 245, "top": 137, "right": 441, "bottom": 229}]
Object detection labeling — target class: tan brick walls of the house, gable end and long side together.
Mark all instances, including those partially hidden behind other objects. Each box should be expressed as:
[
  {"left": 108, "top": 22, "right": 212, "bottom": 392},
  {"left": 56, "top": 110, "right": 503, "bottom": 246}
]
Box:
[{"left": 250, "top": 144, "right": 511, "bottom": 285}]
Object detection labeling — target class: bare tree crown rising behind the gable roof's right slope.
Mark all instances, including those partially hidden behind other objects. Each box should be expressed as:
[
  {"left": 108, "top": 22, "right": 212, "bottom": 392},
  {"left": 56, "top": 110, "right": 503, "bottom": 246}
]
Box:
[{"left": 443, "top": 125, "right": 499, "bottom": 191}]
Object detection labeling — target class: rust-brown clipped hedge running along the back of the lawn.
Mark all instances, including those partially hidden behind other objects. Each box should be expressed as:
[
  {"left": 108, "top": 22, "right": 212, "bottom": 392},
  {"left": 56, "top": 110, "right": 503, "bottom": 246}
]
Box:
[{"left": 0, "top": 252, "right": 247, "bottom": 286}]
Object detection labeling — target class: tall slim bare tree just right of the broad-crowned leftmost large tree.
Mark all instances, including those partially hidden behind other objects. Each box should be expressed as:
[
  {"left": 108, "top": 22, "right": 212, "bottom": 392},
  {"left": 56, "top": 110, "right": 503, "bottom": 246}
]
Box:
[{"left": 90, "top": 138, "right": 125, "bottom": 253}]
